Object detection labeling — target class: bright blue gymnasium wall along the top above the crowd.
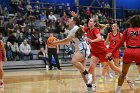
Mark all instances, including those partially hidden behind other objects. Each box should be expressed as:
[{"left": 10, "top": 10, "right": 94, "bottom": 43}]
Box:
[{"left": 0, "top": 0, "right": 140, "bottom": 9}]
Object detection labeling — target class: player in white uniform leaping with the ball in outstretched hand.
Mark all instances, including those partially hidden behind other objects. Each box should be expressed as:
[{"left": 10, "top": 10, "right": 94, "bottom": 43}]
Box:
[{"left": 52, "top": 17, "right": 92, "bottom": 91}]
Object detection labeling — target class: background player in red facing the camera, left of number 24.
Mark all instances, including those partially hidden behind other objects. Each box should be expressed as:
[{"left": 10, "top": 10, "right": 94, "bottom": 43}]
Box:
[{"left": 105, "top": 23, "right": 122, "bottom": 80}]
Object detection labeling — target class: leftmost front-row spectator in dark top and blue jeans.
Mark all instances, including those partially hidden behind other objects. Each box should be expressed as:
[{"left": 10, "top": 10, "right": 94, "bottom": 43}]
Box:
[{"left": 5, "top": 41, "right": 13, "bottom": 61}]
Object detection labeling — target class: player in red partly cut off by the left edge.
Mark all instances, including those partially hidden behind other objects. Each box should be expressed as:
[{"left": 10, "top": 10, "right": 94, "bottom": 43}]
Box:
[{"left": 0, "top": 40, "right": 7, "bottom": 88}]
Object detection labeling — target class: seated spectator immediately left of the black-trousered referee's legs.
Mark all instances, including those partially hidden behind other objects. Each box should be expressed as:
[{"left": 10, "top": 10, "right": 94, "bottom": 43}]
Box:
[{"left": 38, "top": 48, "right": 49, "bottom": 67}]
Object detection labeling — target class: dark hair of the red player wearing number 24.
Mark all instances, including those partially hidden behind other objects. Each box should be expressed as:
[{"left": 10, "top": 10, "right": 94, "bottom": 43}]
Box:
[{"left": 127, "top": 15, "right": 140, "bottom": 28}]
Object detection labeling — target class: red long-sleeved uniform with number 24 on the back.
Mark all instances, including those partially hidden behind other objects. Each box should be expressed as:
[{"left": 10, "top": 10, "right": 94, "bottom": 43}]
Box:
[{"left": 112, "top": 28, "right": 140, "bottom": 63}]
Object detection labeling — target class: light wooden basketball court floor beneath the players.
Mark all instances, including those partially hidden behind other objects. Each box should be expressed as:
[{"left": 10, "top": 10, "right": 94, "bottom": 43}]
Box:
[{"left": 0, "top": 65, "right": 140, "bottom": 93}]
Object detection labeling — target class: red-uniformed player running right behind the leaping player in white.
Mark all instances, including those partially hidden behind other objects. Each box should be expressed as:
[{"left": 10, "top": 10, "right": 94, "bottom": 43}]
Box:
[{"left": 81, "top": 18, "right": 121, "bottom": 91}]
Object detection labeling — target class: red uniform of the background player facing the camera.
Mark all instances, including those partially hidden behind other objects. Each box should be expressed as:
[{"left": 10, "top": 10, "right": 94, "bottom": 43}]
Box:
[{"left": 108, "top": 32, "right": 121, "bottom": 58}]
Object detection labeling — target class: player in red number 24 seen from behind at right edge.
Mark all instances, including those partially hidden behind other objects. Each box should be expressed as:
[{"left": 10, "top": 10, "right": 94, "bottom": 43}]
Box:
[{"left": 107, "top": 15, "right": 140, "bottom": 93}]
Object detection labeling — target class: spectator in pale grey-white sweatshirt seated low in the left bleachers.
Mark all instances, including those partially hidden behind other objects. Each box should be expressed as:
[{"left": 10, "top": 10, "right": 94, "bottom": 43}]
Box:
[{"left": 19, "top": 40, "right": 33, "bottom": 60}]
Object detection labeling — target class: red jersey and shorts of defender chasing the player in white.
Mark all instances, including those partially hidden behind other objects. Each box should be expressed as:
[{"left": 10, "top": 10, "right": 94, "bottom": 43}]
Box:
[{"left": 84, "top": 27, "right": 108, "bottom": 62}]
